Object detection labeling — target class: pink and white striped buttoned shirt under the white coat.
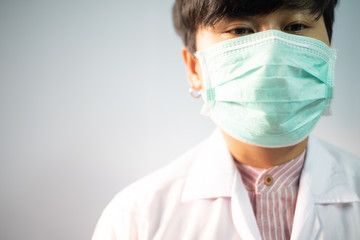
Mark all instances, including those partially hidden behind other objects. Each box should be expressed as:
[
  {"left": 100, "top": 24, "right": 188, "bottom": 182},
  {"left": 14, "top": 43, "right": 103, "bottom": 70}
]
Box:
[{"left": 236, "top": 151, "right": 305, "bottom": 240}]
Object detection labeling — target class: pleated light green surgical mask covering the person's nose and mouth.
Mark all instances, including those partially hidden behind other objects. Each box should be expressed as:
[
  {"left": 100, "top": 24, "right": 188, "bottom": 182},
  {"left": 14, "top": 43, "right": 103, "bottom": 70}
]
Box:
[{"left": 196, "top": 30, "right": 336, "bottom": 147}]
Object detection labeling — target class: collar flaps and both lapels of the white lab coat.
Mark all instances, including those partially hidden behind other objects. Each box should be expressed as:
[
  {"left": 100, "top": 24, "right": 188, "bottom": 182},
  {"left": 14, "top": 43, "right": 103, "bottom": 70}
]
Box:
[{"left": 182, "top": 129, "right": 360, "bottom": 239}]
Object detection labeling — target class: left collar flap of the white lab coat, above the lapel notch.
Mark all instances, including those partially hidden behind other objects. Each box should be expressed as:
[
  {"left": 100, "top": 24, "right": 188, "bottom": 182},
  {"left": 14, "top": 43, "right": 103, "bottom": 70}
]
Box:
[{"left": 182, "top": 129, "right": 237, "bottom": 202}]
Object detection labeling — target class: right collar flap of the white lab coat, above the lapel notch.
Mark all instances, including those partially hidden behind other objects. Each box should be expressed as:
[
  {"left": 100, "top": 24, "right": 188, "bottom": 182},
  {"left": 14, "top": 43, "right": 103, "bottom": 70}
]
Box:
[{"left": 300, "top": 136, "right": 360, "bottom": 204}]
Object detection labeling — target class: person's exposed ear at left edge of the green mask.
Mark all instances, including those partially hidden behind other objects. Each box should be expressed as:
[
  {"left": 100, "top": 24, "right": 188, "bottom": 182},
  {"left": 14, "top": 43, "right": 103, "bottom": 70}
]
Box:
[{"left": 181, "top": 47, "right": 202, "bottom": 91}]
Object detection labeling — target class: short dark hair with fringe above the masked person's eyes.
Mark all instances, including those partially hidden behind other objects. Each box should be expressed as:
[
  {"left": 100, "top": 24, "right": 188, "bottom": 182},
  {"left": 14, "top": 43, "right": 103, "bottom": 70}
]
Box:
[{"left": 173, "top": 0, "right": 338, "bottom": 53}]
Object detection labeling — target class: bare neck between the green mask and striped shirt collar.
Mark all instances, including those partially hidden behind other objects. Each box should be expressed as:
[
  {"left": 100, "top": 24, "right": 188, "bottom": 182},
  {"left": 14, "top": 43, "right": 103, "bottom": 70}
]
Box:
[{"left": 221, "top": 131, "right": 308, "bottom": 168}]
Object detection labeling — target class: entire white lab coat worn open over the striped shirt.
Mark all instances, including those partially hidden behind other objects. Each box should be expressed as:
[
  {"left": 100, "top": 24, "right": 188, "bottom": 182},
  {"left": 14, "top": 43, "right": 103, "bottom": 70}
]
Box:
[{"left": 93, "top": 130, "right": 360, "bottom": 240}]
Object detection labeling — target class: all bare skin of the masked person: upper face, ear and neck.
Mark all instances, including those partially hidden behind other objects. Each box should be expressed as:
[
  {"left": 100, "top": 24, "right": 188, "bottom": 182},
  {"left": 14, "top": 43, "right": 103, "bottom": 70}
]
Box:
[{"left": 182, "top": 8, "right": 330, "bottom": 168}]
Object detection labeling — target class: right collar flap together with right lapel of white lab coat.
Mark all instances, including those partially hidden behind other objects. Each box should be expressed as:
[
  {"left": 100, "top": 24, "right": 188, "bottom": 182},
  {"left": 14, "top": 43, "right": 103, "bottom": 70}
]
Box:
[{"left": 291, "top": 137, "right": 359, "bottom": 239}]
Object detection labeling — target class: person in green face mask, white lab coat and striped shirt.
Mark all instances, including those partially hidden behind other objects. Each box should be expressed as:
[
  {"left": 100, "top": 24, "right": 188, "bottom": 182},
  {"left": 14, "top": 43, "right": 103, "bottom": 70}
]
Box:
[{"left": 93, "top": 0, "right": 360, "bottom": 240}]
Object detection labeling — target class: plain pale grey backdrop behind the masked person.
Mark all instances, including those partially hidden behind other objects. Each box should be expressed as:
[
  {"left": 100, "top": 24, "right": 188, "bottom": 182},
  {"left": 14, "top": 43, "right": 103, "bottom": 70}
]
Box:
[{"left": 0, "top": 0, "right": 360, "bottom": 240}]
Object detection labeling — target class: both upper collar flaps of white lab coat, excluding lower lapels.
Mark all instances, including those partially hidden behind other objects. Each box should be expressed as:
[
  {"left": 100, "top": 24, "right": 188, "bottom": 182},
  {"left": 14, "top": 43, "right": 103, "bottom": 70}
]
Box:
[{"left": 182, "top": 129, "right": 360, "bottom": 204}]
